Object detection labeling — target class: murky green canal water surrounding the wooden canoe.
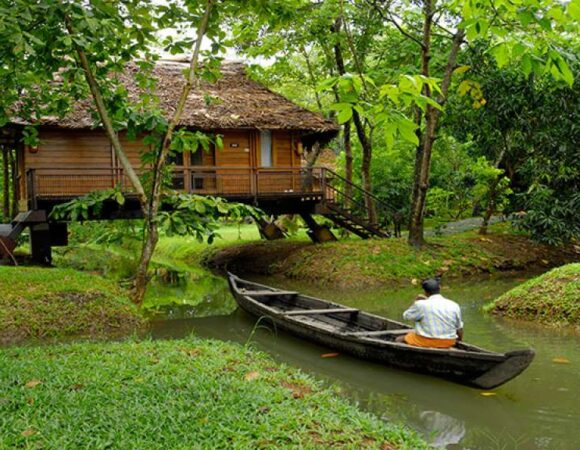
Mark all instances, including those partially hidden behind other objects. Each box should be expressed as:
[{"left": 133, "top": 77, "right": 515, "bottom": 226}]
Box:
[{"left": 151, "top": 272, "right": 580, "bottom": 450}]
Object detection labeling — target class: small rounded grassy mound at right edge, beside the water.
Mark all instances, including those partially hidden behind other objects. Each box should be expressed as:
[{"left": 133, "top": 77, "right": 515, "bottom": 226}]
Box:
[{"left": 486, "top": 264, "right": 580, "bottom": 326}]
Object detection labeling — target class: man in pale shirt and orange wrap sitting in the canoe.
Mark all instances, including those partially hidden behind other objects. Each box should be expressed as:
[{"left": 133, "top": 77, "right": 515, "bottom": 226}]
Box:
[{"left": 397, "top": 279, "right": 463, "bottom": 348}]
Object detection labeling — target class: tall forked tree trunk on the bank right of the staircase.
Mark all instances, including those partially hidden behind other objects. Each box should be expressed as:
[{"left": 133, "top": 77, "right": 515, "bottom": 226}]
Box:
[{"left": 408, "top": 0, "right": 464, "bottom": 246}]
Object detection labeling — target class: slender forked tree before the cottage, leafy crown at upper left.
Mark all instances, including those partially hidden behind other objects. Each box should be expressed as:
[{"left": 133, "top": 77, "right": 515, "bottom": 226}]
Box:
[{"left": 1, "top": 0, "right": 260, "bottom": 303}]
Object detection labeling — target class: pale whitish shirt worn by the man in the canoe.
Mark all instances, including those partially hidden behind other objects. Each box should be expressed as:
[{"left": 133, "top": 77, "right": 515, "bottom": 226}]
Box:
[{"left": 403, "top": 294, "right": 463, "bottom": 339}]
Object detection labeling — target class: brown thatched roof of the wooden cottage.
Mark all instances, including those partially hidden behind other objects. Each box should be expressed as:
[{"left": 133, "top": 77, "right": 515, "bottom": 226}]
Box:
[{"left": 13, "top": 61, "right": 338, "bottom": 141}]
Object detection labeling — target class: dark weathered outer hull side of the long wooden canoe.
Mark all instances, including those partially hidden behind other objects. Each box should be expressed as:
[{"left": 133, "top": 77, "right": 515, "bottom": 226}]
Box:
[{"left": 229, "top": 275, "right": 534, "bottom": 389}]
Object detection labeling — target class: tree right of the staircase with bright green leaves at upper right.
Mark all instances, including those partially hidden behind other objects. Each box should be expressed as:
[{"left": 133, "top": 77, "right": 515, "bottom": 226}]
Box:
[{"left": 369, "top": 0, "right": 579, "bottom": 245}]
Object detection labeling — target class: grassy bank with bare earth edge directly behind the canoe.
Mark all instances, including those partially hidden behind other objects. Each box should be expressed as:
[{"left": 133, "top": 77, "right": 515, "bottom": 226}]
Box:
[{"left": 206, "top": 226, "right": 580, "bottom": 287}]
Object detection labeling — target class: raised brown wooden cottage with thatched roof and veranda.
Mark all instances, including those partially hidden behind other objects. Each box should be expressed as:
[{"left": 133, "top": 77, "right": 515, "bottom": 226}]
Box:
[{"left": 0, "top": 61, "right": 385, "bottom": 261}]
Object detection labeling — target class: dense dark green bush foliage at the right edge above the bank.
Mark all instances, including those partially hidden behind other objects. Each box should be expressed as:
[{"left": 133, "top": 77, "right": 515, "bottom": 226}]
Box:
[{"left": 446, "top": 49, "right": 580, "bottom": 244}]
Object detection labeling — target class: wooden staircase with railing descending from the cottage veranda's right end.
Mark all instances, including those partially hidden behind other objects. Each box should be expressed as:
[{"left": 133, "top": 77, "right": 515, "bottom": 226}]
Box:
[{"left": 319, "top": 169, "right": 394, "bottom": 239}]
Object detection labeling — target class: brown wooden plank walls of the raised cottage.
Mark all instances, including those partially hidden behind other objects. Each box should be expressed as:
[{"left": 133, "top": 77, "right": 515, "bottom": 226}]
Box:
[{"left": 22, "top": 128, "right": 300, "bottom": 200}]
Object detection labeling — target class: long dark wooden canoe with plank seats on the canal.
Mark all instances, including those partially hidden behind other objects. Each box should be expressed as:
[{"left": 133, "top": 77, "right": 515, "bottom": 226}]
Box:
[{"left": 228, "top": 273, "right": 534, "bottom": 389}]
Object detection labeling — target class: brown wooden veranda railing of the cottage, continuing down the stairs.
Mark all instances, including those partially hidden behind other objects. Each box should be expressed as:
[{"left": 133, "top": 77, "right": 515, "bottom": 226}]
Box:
[{"left": 27, "top": 166, "right": 395, "bottom": 235}]
